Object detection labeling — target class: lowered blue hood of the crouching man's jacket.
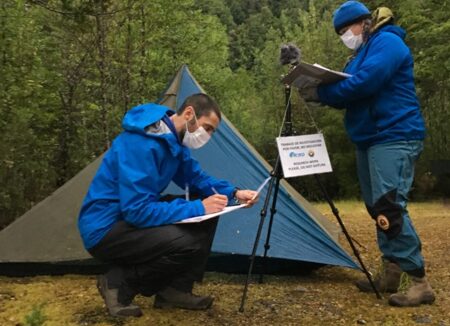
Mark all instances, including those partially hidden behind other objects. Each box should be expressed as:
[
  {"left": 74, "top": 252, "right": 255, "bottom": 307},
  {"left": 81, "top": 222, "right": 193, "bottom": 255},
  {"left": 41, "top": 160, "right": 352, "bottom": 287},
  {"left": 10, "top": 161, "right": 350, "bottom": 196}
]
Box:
[{"left": 122, "top": 103, "right": 173, "bottom": 134}]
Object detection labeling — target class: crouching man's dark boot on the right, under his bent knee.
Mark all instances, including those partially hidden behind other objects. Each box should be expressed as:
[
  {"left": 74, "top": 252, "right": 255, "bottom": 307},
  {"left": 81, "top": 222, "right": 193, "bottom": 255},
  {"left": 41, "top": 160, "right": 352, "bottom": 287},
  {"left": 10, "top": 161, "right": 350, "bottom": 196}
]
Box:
[{"left": 153, "top": 287, "right": 214, "bottom": 310}]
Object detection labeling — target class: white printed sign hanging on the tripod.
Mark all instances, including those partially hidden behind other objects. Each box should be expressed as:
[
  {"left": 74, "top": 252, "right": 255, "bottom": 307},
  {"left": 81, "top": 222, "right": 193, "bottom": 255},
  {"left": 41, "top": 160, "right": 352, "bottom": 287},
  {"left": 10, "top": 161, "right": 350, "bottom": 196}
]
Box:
[{"left": 277, "top": 134, "right": 333, "bottom": 178}]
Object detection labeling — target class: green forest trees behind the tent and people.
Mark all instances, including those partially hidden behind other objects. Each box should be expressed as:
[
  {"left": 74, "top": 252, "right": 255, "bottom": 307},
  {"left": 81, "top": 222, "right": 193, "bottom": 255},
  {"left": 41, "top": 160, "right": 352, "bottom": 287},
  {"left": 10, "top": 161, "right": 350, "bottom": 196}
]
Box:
[{"left": 0, "top": 0, "right": 450, "bottom": 229}]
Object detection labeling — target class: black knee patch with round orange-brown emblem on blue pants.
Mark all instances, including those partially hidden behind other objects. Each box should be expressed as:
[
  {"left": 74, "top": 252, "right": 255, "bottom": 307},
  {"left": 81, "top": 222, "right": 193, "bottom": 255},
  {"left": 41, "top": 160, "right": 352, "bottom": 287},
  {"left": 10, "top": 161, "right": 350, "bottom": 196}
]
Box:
[{"left": 366, "top": 189, "right": 403, "bottom": 240}]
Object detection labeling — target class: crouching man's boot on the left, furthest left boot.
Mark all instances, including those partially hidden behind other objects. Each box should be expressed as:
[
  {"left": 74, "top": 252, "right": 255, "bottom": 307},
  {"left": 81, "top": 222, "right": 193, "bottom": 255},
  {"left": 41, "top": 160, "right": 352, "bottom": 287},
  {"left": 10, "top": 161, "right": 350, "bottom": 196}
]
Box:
[{"left": 97, "top": 275, "right": 142, "bottom": 317}]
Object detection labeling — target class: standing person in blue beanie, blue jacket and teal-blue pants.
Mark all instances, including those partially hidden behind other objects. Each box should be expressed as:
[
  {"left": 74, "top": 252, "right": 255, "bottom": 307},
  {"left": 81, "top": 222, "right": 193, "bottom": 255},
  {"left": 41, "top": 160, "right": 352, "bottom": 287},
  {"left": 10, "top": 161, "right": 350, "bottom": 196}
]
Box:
[{"left": 300, "top": 1, "right": 435, "bottom": 306}]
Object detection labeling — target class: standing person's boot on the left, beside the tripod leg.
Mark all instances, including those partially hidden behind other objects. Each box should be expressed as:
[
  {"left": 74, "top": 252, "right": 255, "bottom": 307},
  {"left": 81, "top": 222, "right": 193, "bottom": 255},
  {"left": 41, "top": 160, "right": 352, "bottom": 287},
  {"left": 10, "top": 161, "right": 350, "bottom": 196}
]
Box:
[{"left": 355, "top": 260, "right": 402, "bottom": 293}]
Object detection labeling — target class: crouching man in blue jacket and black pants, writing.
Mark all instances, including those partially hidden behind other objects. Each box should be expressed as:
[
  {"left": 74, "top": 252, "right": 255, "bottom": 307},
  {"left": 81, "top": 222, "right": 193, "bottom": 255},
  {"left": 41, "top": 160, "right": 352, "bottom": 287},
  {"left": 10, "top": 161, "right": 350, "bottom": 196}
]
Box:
[{"left": 78, "top": 94, "right": 257, "bottom": 316}]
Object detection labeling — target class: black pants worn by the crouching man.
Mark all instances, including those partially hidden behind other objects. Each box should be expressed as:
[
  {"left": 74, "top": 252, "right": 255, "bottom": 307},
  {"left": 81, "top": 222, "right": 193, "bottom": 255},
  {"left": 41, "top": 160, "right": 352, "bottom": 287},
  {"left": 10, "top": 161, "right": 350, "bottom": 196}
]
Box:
[{"left": 89, "top": 218, "right": 218, "bottom": 303}]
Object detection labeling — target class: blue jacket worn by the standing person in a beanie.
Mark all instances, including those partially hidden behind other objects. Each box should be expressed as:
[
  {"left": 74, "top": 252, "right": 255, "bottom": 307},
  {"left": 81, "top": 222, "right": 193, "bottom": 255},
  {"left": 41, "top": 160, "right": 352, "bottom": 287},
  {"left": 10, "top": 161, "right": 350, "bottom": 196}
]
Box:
[{"left": 318, "top": 25, "right": 425, "bottom": 149}]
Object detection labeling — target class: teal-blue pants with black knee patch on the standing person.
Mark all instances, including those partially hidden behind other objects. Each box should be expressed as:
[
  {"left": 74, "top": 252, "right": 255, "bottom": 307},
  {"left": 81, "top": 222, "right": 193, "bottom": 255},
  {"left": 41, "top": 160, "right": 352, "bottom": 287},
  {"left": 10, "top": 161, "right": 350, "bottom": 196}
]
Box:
[{"left": 356, "top": 140, "right": 424, "bottom": 274}]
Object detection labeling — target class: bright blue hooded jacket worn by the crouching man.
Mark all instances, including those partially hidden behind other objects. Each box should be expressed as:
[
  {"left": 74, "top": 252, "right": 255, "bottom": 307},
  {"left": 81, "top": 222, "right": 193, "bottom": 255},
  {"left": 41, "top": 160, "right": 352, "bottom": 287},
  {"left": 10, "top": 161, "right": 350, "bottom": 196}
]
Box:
[{"left": 78, "top": 104, "right": 235, "bottom": 249}]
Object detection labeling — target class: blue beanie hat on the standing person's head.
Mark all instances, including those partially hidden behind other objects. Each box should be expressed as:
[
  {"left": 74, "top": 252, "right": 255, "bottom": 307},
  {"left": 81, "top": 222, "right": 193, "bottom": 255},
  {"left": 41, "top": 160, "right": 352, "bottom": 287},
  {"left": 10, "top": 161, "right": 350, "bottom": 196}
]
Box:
[{"left": 333, "top": 1, "right": 370, "bottom": 33}]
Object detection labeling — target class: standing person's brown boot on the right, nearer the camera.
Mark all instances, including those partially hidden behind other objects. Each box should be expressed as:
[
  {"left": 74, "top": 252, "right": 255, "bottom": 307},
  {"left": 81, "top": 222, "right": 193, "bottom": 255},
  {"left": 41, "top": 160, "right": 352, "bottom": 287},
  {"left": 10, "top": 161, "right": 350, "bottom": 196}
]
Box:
[{"left": 389, "top": 273, "right": 435, "bottom": 307}]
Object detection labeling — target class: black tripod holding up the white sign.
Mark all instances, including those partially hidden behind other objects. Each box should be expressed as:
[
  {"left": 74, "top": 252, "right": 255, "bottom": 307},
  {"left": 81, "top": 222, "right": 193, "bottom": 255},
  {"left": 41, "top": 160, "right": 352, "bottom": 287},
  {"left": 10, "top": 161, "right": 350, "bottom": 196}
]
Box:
[{"left": 239, "top": 85, "right": 382, "bottom": 312}]
